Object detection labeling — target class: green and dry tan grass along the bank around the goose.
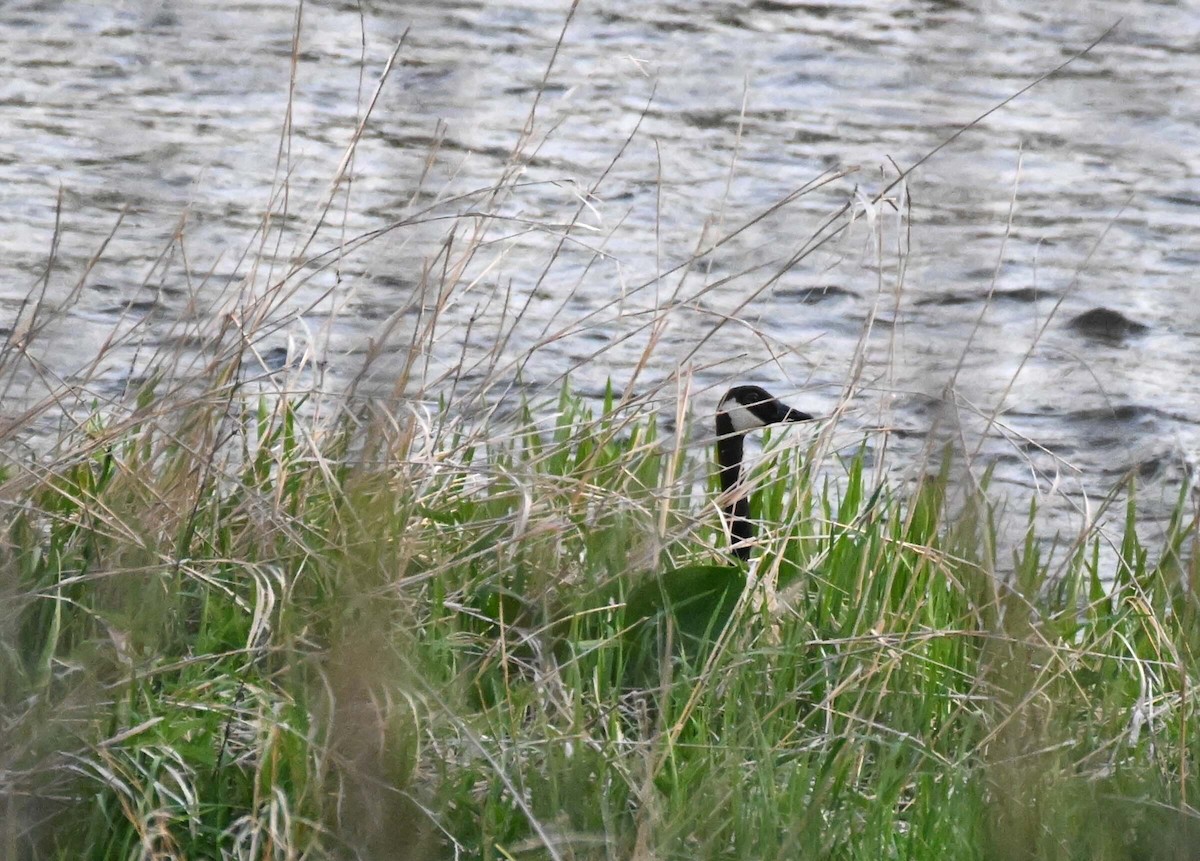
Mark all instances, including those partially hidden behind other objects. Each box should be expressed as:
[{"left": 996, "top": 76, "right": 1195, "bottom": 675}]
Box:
[{"left": 0, "top": 13, "right": 1200, "bottom": 861}]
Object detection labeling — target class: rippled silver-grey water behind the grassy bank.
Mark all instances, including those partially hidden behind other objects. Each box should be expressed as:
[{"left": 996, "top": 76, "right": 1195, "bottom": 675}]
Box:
[{"left": 0, "top": 0, "right": 1200, "bottom": 558}]
